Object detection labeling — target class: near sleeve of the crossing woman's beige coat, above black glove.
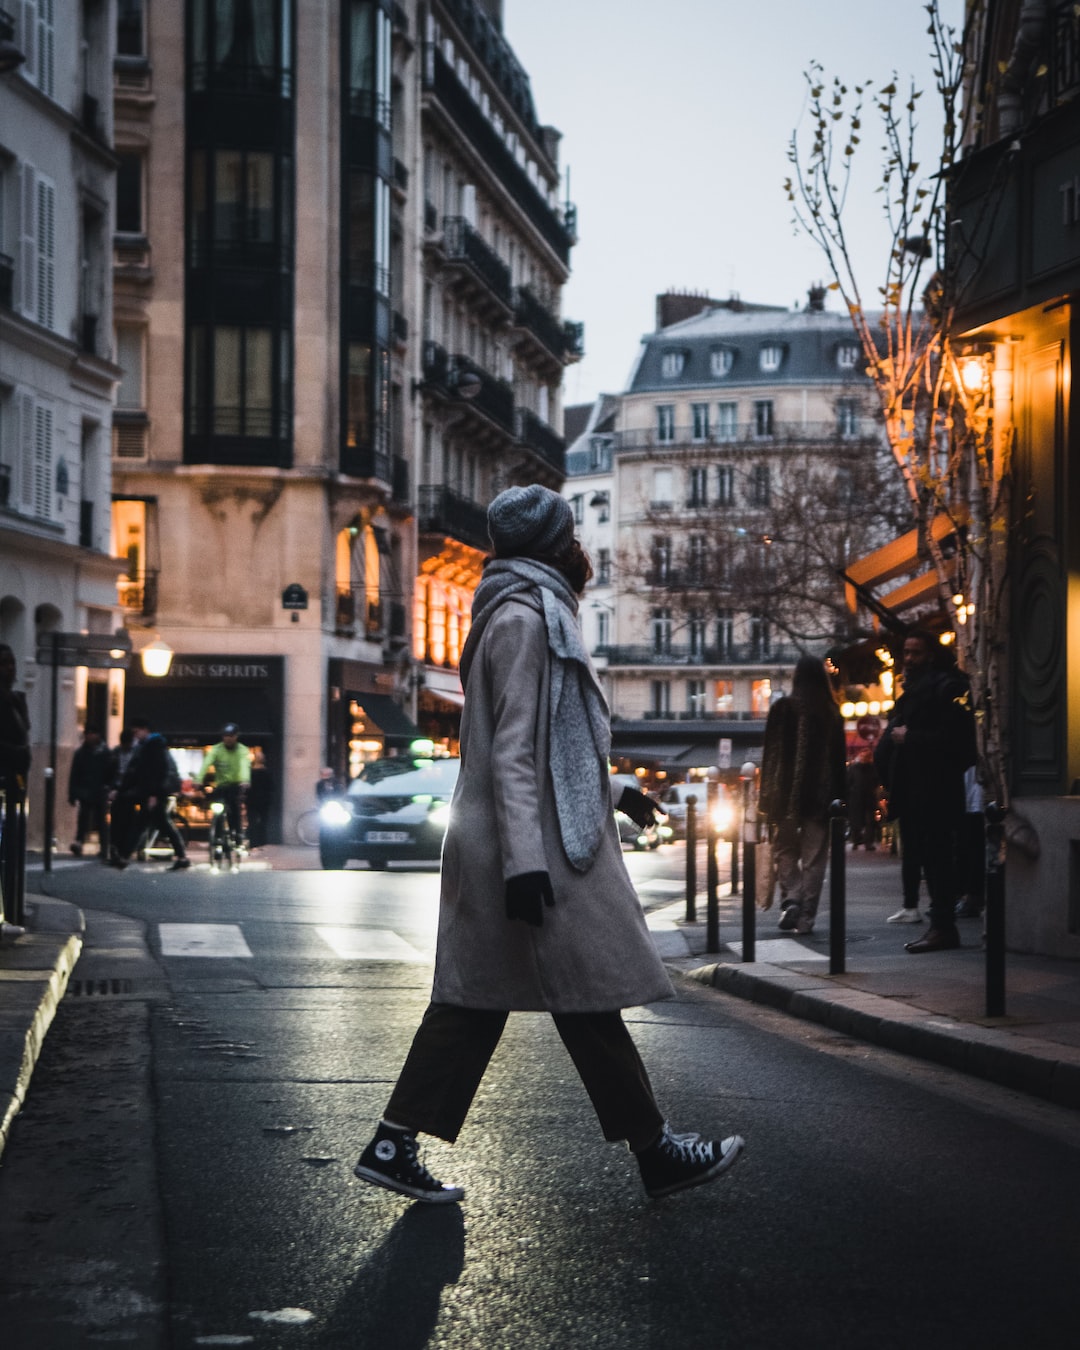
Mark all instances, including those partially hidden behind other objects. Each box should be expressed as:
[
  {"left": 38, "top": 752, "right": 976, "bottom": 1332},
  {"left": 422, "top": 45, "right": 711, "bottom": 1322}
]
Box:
[{"left": 485, "top": 605, "right": 549, "bottom": 880}]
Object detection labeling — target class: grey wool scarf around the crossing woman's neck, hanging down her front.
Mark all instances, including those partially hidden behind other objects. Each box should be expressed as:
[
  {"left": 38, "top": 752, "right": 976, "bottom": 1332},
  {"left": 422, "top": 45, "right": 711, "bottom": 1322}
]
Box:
[{"left": 460, "top": 558, "right": 612, "bottom": 872}]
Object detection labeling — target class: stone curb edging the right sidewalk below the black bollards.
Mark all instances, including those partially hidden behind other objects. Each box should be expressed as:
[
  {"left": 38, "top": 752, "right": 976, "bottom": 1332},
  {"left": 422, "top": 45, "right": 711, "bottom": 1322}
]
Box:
[{"left": 671, "top": 963, "right": 1080, "bottom": 1110}]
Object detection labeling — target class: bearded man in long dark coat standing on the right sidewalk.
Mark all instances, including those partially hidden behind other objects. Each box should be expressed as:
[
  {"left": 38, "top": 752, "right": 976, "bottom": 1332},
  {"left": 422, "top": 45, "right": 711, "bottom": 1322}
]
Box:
[{"left": 873, "top": 632, "right": 975, "bottom": 954}]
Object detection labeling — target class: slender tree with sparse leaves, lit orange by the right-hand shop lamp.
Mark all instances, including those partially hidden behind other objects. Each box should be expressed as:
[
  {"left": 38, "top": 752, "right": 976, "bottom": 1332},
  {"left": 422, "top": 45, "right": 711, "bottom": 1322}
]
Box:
[{"left": 784, "top": 0, "right": 1013, "bottom": 805}]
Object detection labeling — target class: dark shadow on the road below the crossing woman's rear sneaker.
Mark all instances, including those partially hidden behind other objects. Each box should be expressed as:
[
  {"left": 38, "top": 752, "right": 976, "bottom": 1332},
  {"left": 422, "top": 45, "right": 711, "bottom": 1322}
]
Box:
[{"left": 320, "top": 1204, "right": 464, "bottom": 1350}]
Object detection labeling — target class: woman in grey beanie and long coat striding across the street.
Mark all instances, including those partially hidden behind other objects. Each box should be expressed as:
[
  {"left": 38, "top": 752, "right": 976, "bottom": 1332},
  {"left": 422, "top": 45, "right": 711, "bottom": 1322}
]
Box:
[{"left": 355, "top": 485, "right": 743, "bottom": 1203}]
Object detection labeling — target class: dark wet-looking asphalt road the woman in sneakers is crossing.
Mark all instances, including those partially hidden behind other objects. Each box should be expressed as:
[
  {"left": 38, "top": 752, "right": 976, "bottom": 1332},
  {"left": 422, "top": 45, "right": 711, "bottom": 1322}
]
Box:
[{"left": 0, "top": 849, "right": 1080, "bottom": 1350}]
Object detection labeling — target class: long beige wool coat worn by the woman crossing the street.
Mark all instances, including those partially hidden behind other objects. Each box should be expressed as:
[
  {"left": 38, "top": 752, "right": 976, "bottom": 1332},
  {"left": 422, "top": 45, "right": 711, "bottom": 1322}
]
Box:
[{"left": 432, "top": 598, "right": 674, "bottom": 1013}]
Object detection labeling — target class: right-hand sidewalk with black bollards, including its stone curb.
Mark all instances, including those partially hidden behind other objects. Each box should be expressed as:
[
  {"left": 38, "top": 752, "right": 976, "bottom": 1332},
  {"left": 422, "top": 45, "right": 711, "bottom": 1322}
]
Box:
[{"left": 649, "top": 851, "right": 1080, "bottom": 1108}]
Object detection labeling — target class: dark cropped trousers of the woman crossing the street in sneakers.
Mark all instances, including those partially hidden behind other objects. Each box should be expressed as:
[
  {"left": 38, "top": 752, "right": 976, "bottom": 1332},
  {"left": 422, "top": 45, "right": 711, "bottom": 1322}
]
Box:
[{"left": 386, "top": 1003, "right": 664, "bottom": 1150}]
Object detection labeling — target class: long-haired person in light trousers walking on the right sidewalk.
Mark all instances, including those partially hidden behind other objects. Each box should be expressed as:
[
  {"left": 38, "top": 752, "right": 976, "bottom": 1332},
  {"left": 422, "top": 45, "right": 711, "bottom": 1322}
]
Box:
[{"left": 759, "top": 656, "right": 846, "bottom": 937}]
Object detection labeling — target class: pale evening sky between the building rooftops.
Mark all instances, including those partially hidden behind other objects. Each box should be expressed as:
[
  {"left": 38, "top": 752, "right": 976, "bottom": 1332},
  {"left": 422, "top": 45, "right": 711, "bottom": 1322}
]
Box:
[{"left": 504, "top": 0, "right": 963, "bottom": 404}]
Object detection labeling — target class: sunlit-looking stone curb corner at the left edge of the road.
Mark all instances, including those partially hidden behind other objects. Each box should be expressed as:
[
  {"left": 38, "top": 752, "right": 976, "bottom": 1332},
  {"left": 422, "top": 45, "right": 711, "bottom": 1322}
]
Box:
[{"left": 0, "top": 896, "right": 85, "bottom": 1157}]
